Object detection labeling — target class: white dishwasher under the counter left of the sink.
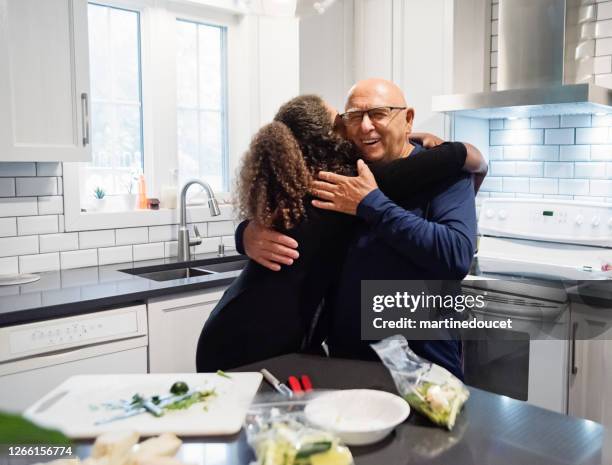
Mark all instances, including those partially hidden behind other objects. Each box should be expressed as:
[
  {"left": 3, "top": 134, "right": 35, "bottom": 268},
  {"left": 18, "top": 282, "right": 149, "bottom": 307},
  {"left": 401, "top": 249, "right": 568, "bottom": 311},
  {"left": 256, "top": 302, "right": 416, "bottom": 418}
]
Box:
[{"left": 0, "top": 304, "right": 148, "bottom": 413}]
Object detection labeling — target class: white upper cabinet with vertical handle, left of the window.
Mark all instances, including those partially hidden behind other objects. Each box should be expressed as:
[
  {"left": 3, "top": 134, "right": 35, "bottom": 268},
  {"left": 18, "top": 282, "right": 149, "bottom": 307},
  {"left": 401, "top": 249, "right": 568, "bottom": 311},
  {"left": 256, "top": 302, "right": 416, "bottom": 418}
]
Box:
[{"left": 0, "top": 0, "right": 91, "bottom": 161}]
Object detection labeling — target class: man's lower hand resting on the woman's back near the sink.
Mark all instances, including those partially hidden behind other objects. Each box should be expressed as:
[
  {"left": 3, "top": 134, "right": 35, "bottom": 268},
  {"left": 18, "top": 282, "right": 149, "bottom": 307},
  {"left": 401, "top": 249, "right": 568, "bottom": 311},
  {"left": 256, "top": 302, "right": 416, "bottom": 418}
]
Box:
[{"left": 242, "top": 221, "right": 300, "bottom": 271}]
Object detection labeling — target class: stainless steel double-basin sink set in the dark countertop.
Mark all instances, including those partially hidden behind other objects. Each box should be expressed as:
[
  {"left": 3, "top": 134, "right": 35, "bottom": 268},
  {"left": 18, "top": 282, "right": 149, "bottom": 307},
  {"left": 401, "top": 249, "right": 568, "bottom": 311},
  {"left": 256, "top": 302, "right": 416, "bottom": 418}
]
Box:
[{"left": 119, "top": 256, "right": 247, "bottom": 281}]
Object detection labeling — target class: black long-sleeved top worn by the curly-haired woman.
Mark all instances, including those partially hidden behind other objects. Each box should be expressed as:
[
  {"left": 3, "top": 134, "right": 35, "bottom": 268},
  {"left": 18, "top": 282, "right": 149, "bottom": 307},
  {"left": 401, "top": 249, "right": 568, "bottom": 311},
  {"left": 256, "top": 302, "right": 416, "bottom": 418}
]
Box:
[{"left": 196, "top": 142, "right": 467, "bottom": 372}]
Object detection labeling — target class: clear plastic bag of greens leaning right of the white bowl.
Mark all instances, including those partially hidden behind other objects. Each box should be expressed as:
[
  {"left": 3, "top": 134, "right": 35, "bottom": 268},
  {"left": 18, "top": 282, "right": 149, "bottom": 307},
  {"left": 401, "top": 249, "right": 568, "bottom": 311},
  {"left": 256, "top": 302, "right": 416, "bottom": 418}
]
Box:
[{"left": 372, "top": 336, "right": 470, "bottom": 431}]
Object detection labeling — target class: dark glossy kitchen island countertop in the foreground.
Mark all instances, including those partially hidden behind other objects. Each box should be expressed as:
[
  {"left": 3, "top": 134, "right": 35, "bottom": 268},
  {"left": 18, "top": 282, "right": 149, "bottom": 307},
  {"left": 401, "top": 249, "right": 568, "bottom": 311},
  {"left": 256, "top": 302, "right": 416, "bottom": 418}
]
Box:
[{"left": 77, "top": 354, "right": 612, "bottom": 465}]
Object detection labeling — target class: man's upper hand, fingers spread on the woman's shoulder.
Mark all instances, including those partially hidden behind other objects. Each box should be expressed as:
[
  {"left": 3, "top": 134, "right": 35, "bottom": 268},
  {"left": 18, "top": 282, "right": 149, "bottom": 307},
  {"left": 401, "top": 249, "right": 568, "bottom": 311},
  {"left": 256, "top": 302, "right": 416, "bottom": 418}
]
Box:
[{"left": 311, "top": 160, "right": 378, "bottom": 215}]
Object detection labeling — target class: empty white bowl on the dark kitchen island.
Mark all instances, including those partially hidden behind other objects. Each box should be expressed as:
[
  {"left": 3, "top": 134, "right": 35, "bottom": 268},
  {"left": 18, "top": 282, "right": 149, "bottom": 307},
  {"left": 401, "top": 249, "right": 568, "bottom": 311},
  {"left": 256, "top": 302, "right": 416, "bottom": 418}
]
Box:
[{"left": 304, "top": 389, "right": 410, "bottom": 446}]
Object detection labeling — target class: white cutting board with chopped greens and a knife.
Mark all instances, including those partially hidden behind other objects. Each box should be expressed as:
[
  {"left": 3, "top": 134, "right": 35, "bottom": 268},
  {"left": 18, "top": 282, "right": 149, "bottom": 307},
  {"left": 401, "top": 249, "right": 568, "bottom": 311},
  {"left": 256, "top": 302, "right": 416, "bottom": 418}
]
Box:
[{"left": 24, "top": 373, "right": 262, "bottom": 439}]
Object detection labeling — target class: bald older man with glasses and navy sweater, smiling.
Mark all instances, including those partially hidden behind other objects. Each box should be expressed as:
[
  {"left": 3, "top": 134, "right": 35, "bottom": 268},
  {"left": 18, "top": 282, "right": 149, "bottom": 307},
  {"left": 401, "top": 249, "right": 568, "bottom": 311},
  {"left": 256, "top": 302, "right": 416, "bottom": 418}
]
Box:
[{"left": 236, "top": 79, "right": 476, "bottom": 377}]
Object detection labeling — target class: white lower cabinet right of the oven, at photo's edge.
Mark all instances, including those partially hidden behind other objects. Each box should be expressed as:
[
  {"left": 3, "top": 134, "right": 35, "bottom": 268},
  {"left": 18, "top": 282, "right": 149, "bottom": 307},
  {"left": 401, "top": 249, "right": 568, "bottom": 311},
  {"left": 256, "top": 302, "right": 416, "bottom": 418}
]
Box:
[{"left": 568, "top": 304, "right": 612, "bottom": 427}]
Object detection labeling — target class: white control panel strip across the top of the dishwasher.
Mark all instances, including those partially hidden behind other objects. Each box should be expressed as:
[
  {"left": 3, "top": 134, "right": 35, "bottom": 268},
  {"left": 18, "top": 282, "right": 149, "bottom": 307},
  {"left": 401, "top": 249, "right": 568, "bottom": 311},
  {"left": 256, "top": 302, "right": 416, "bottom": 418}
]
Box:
[{"left": 0, "top": 305, "right": 146, "bottom": 362}]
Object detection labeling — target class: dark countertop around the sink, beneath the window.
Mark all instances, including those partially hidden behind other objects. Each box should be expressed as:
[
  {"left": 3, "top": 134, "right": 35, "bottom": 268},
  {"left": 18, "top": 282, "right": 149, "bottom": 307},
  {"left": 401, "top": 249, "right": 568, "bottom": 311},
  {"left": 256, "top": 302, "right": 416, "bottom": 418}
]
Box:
[{"left": 0, "top": 253, "right": 245, "bottom": 327}]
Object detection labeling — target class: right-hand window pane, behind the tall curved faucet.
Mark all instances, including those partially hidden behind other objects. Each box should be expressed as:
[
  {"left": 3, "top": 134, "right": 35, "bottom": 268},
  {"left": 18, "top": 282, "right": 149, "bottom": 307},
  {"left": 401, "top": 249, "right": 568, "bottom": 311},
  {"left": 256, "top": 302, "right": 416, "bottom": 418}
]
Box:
[{"left": 176, "top": 20, "right": 228, "bottom": 191}]
